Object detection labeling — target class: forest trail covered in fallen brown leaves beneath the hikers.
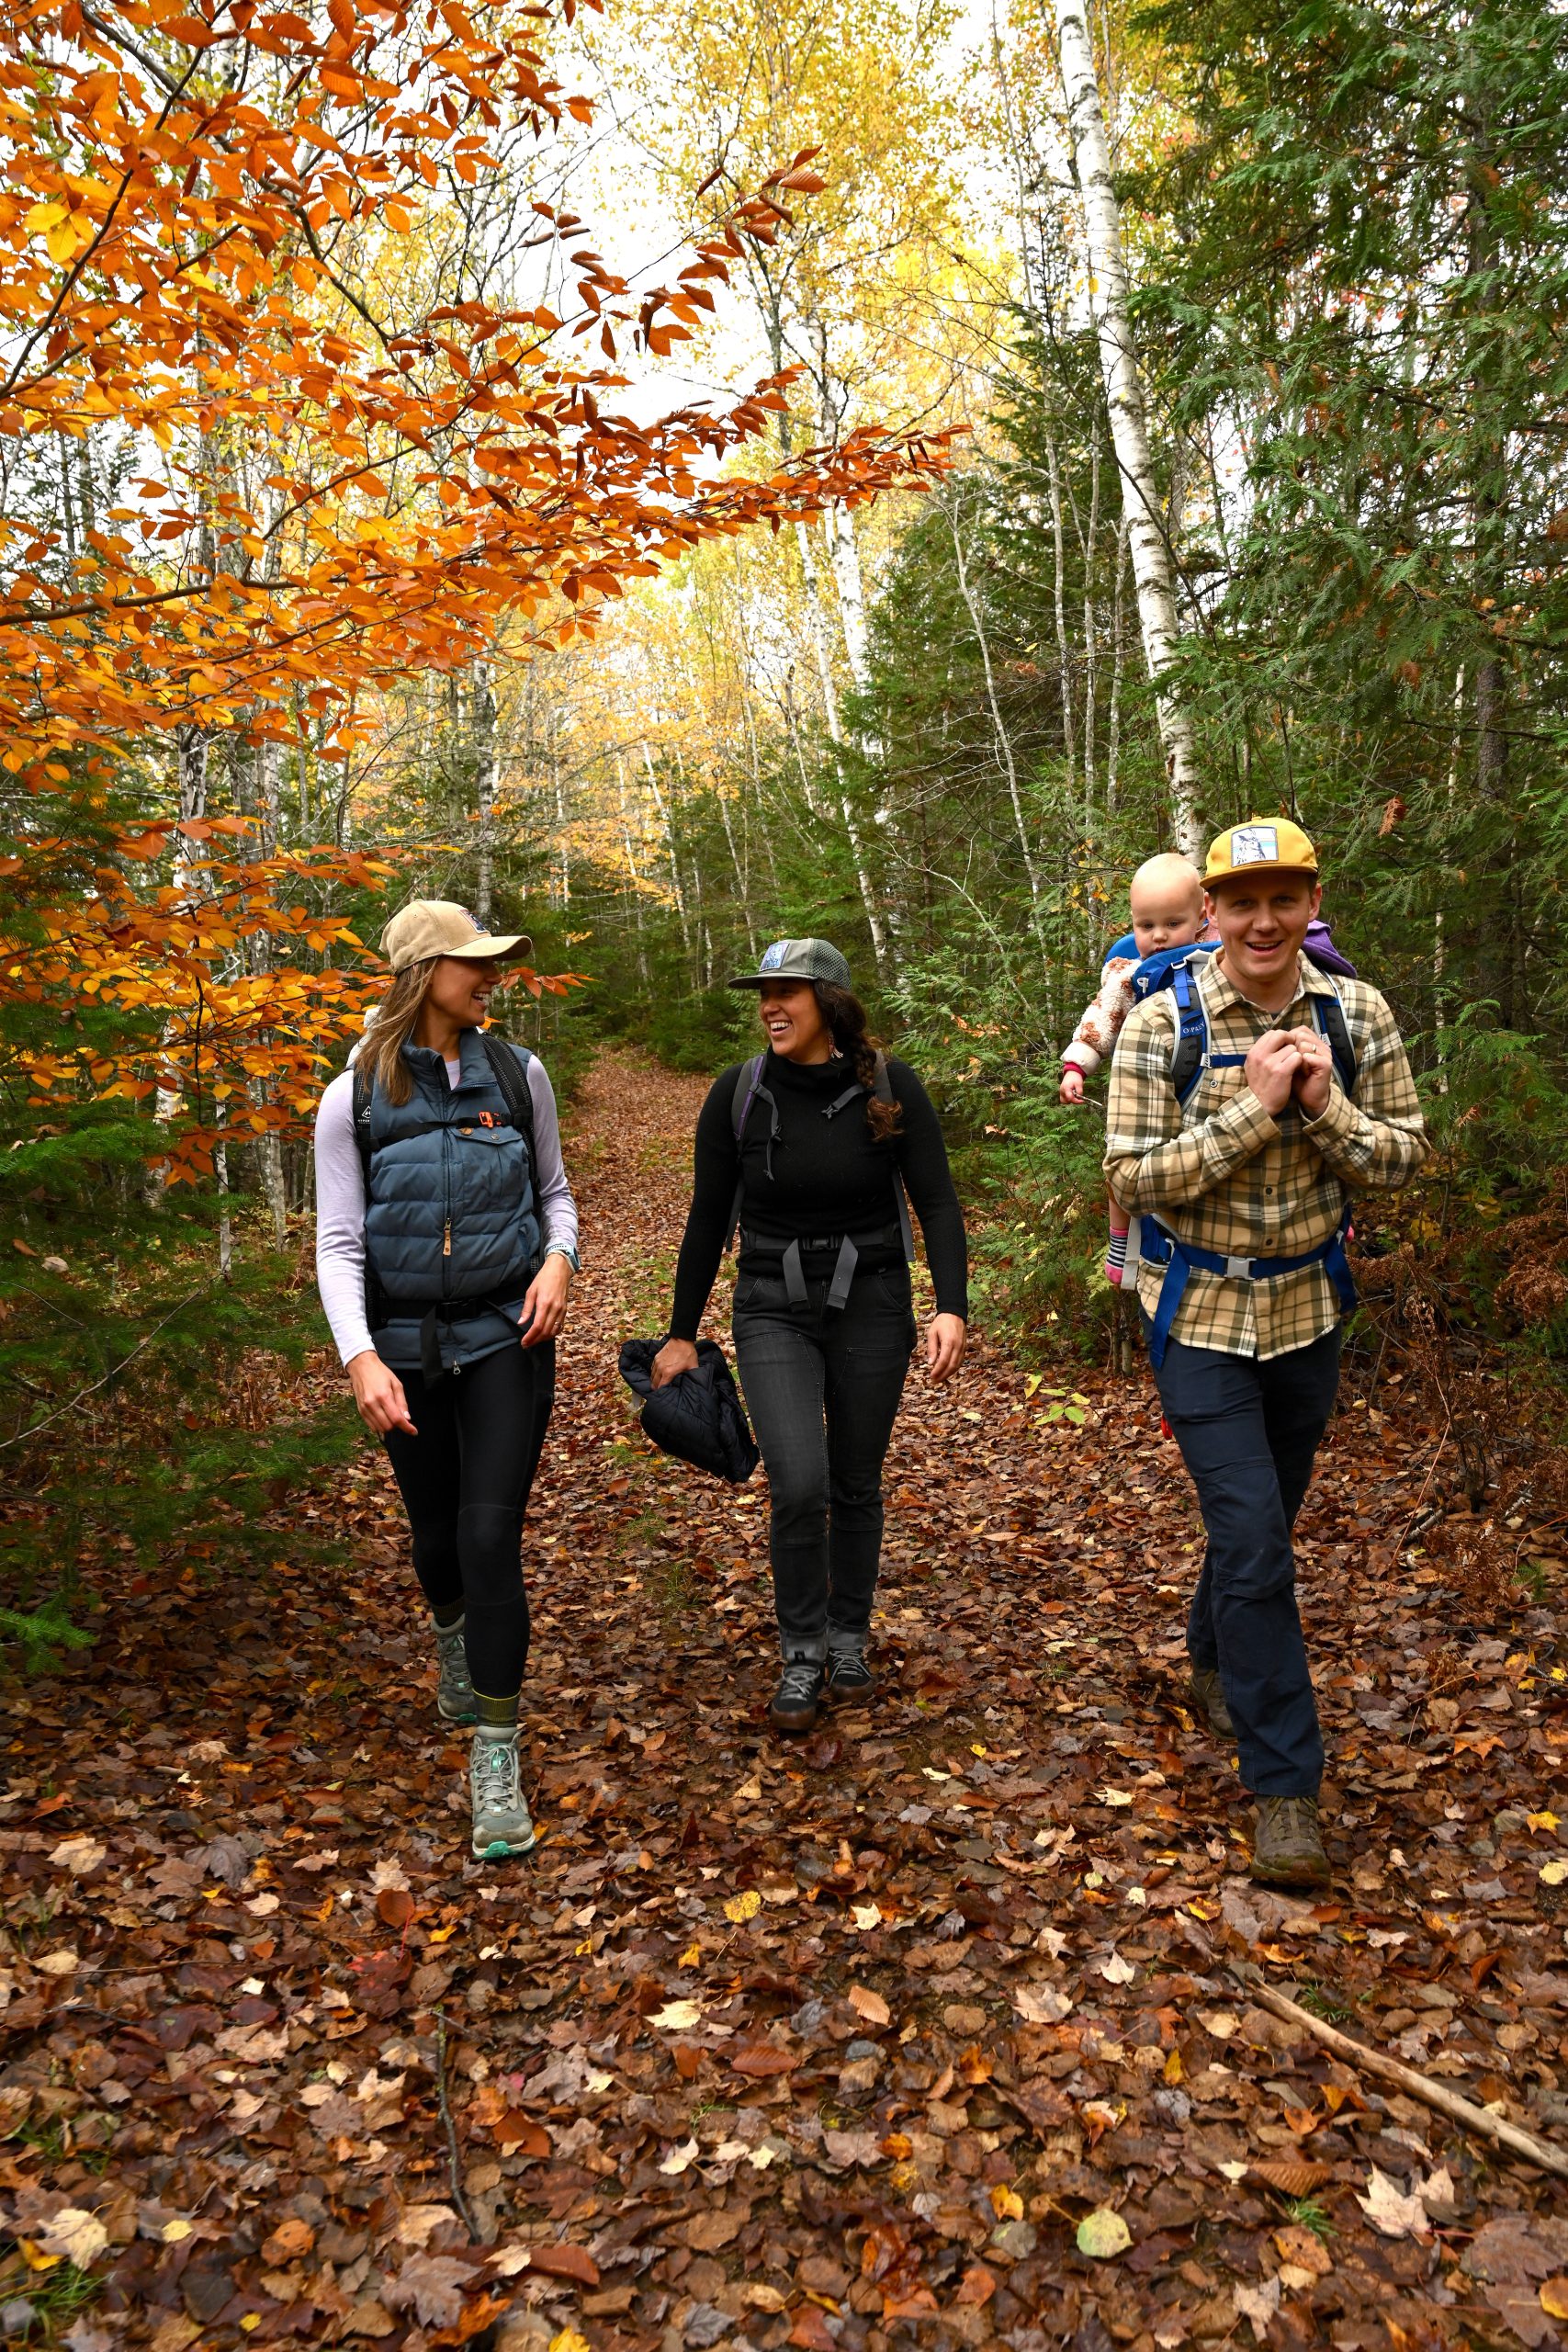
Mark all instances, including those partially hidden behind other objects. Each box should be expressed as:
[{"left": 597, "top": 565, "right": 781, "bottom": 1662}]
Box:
[{"left": 0, "top": 1056, "right": 1568, "bottom": 2352}]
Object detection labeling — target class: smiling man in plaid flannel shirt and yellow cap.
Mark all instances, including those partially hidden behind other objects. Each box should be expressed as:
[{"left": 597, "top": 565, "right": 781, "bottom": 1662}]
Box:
[{"left": 1105, "top": 819, "right": 1427, "bottom": 1884}]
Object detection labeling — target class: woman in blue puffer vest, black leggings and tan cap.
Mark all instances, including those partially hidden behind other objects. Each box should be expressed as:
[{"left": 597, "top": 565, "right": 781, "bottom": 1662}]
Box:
[{"left": 315, "top": 899, "right": 579, "bottom": 1858}]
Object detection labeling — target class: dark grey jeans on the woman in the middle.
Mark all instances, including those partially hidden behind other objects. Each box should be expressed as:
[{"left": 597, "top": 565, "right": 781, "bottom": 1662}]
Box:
[{"left": 733, "top": 1265, "right": 915, "bottom": 1660}]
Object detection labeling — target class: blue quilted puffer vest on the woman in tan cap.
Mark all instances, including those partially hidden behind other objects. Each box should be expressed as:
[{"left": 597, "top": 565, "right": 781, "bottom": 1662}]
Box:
[{"left": 365, "top": 1030, "right": 541, "bottom": 1376}]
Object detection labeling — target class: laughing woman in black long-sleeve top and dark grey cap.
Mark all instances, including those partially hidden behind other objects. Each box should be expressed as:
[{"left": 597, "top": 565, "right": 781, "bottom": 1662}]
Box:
[{"left": 653, "top": 938, "right": 968, "bottom": 1731}]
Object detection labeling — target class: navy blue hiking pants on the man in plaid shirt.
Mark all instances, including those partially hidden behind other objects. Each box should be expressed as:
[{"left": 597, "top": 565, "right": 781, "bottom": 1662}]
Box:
[{"left": 1145, "top": 1317, "right": 1340, "bottom": 1797}]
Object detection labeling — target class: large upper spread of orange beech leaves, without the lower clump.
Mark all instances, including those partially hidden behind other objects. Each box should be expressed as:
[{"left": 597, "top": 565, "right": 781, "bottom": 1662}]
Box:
[{"left": 0, "top": 0, "right": 942, "bottom": 772}]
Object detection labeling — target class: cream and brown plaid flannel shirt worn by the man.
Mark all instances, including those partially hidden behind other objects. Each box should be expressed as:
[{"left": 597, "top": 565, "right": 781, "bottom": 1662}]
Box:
[{"left": 1105, "top": 955, "right": 1427, "bottom": 1357}]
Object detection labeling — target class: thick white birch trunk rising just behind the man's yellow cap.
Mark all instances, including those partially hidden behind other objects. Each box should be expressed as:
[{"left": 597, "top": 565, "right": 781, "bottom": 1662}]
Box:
[{"left": 1055, "top": 0, "right": 1201, "bottom": 858}]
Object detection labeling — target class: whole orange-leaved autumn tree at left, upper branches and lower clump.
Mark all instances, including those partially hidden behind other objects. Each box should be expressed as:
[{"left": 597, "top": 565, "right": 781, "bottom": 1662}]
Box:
[{"left": 0, "top": 0, "right": 942, "bottom": 1173}]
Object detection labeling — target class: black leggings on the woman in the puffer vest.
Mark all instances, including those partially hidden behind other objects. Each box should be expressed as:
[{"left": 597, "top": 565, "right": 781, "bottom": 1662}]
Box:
[{"left": 383, "top": 1339, "right": 555, "bottom": 1698}]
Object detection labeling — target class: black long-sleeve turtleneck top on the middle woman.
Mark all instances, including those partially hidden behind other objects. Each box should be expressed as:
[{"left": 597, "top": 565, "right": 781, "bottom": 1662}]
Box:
[{"left": 670, "top": 1054, "right": 968, "bottom": 1340}]
